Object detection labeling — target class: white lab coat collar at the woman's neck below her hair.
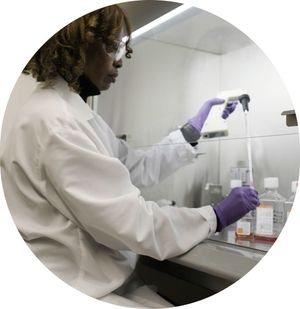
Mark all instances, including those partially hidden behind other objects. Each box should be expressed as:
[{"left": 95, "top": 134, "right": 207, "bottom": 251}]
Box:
[{"left": 54, "top": 77, "right": 94, "bottom": 121}]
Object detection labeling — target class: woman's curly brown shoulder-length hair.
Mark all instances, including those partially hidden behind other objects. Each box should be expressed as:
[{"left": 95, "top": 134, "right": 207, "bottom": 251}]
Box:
[{"left": 23, "top": 5, "right": 132, "bottom": 93}]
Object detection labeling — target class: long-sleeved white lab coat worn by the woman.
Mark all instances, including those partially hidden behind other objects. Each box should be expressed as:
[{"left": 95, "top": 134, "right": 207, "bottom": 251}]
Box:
[{"left": 1, "top": 76, "right": 216, "bottom": 304}]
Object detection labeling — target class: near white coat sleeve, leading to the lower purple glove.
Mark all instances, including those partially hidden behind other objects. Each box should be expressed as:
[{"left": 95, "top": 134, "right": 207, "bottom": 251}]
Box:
[{"left": 40, "top": 128, "right": 216, "bottom": 260}]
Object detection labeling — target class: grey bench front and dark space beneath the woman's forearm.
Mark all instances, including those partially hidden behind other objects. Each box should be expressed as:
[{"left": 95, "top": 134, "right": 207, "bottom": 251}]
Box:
[{"left": 137, "top": 231, "right": 273, "bottom": 306}]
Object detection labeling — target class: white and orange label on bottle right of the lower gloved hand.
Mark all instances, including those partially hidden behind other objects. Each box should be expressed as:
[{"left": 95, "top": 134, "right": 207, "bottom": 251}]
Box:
[{"left": 256, "top": 204, "right": 273, "bottom": 235}]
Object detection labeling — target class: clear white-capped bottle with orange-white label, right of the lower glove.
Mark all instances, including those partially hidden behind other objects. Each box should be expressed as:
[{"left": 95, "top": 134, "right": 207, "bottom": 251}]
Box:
[{"left": 255, "top": 177, "right": 286, "bottom": 241}]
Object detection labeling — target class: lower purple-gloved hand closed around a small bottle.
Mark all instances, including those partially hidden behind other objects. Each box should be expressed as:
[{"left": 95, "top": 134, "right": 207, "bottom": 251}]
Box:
[{"left": 214, "top": 186, "right": 259, "bottom": 232}]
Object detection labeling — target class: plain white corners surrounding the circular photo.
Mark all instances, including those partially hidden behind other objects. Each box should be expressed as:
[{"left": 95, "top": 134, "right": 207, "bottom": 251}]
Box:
[{"left": 0, "top": 0, "right": 300, "bottom": 309}]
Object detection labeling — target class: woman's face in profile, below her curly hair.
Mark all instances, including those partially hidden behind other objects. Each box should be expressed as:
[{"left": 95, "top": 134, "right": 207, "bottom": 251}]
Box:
[{"left": 84, "top": 27, "right": 123, "bottom": 91}]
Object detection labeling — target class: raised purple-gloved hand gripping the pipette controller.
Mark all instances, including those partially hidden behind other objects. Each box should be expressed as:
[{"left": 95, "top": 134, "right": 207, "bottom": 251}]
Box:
[{"left": 188, "top": 98, "right": 238, "bottom": 133}]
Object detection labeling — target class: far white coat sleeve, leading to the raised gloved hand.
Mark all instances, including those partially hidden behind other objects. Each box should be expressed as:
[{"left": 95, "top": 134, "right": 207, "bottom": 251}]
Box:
[{"left": 119, "top": 130, "right": 198, "bottom": 188}]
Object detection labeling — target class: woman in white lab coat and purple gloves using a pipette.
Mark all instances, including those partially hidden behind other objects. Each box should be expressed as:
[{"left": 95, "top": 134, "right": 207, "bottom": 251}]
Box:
[{"left": 1, "top": 6, "right": 258, "bottom": 307}]
